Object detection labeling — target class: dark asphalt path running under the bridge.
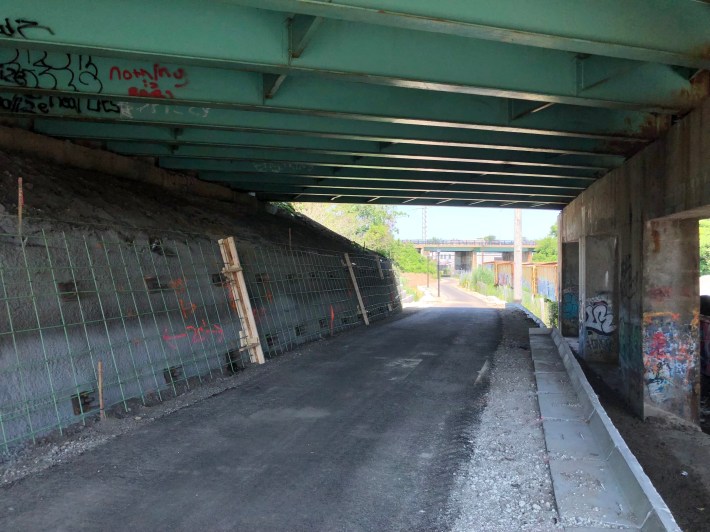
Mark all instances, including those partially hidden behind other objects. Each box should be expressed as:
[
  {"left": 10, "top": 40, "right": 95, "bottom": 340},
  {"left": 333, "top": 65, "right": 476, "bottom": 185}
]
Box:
[{"left": 0, "top": 280, "right": 500, "bottom": 531}]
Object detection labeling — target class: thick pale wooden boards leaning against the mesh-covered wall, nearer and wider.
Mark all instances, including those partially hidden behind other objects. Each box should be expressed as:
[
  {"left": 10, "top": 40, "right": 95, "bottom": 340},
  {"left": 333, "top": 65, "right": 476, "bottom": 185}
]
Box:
[{"left": 219, "top": 236, "right": 265, "bottom": 364}]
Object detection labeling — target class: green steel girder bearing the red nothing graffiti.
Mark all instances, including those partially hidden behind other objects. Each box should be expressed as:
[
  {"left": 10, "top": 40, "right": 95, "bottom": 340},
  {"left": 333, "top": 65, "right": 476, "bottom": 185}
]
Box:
[{"left": 0, "top": 51, "right": 670, "bottom": 139}]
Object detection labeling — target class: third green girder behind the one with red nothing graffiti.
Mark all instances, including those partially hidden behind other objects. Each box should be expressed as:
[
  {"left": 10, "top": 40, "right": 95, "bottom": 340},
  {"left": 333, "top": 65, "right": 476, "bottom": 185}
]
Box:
[{"left": 103, "top": 140, "right": 608, "bottom": 176}]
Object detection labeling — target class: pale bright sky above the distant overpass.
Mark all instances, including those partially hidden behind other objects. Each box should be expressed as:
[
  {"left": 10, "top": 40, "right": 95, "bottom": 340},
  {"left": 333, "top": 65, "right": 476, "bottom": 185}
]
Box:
[{"left": 397, "top": 206, "right": 559, "bottom": 240}]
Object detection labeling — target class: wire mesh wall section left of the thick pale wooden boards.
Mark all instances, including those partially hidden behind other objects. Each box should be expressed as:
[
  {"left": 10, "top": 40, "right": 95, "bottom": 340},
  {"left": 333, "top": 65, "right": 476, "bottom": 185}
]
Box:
[{"left": 0, "top": 228, "right": 249, "bottom": 450}]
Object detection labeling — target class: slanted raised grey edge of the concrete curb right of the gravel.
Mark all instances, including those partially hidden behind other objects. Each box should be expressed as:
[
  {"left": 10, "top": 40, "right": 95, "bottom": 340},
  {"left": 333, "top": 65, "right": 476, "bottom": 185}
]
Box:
[{"left": 513, "top": 304, "right": 681, "bottom": 531}]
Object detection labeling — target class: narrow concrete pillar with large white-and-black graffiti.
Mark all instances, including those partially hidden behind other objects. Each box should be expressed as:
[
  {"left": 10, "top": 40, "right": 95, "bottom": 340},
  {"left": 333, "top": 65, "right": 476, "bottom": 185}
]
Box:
[{"left": 579, "top": 236, "right": 618, "bottom": 363}]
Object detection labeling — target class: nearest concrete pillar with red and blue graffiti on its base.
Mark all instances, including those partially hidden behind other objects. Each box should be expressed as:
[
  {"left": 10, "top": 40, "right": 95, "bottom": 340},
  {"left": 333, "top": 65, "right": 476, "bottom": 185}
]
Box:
[{"left": 642, "top": 219, "right": 700, "bottom": 423}]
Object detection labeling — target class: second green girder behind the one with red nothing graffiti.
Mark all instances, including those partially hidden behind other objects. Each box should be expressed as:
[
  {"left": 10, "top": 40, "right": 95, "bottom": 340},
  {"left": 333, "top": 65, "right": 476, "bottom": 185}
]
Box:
[{"left": 32, "top": 120, "right": 641, "bottom": 164}]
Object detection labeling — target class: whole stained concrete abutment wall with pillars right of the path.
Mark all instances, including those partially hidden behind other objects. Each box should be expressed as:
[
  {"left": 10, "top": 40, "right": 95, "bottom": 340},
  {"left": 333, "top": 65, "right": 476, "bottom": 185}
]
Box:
[{"left": 559, "top": 96, "right": 710, "bottom": 423}]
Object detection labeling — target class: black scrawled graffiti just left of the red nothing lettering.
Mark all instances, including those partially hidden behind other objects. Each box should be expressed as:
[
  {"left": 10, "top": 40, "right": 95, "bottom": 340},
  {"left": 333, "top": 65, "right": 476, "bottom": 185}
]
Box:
[{"left": 0, "top": 49, "right": 103, "bottom": 94}]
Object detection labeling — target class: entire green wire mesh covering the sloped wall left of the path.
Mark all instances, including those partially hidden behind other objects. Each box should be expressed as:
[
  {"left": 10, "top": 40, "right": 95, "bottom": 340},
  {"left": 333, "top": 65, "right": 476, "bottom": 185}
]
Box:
[{"left": 0, "top": 219, "right": 399, "bottom": 450}]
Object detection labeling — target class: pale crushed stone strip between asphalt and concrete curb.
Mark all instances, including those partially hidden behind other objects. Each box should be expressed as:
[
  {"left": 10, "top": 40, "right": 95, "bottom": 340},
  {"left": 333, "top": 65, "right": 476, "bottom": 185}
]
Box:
[{"left": 449, "top": 309, "right": 563, "bottom": 532}]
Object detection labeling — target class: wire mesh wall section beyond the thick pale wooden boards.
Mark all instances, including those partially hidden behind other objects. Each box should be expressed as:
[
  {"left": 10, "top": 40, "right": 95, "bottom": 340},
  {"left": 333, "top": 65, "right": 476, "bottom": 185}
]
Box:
[{"left": 240, "top": 246, "right": 401, "bottom": 356}]
